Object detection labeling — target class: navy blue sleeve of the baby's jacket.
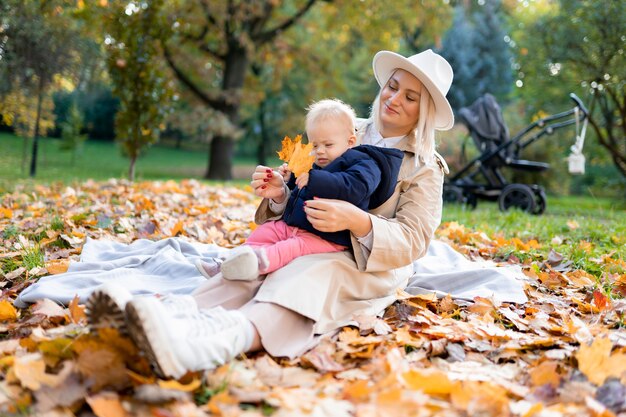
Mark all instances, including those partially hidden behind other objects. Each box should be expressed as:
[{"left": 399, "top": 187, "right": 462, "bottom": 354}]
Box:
[{"left": 306, "top": 159, "right": 381, "bottom": 205}]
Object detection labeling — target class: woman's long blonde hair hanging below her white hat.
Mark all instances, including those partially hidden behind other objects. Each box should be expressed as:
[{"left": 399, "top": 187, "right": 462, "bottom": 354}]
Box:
[{"left": 370, "top": 74, "right": 435, "bottom": 162}]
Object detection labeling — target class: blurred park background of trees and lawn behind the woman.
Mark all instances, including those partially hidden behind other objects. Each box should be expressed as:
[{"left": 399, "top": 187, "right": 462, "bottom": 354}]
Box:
[{"left": 0, "top": 0, "right": 626, "bottom": 201}]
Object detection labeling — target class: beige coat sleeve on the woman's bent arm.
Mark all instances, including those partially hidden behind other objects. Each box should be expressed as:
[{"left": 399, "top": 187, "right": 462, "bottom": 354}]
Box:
[{"left": 352, "top": 158, "right": 443, "bottom": 272}]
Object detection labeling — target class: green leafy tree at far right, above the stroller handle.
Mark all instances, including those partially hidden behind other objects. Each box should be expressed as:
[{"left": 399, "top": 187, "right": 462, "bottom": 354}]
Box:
[{"left": 518, "top": 0, "right": 626, "bottom": 182}]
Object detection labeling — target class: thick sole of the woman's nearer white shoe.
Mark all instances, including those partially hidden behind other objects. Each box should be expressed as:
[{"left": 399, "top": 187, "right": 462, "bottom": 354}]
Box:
[{"left": 126, "top": 299, "right": 187, "bottom": 379}]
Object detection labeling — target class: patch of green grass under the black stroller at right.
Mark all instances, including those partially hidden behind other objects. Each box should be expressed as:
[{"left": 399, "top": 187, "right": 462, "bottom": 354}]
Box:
[{"left": 443, "top": 196, "right": 626, "bottom": 277}]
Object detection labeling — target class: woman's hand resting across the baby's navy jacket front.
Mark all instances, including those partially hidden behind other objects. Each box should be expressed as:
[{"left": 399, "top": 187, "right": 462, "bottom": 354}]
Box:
[{"left": 304, "top": 198, "right": 372, "bottom": 237}]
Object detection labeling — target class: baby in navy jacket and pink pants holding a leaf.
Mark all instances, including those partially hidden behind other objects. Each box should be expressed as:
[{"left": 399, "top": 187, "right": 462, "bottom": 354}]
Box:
[{"left": 196, "top": 99, "right": 404, "bottom": 281}]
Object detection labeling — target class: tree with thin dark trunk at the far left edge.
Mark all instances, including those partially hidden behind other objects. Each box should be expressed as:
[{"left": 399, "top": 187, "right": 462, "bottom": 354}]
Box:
[{"left": 0, "top": 0, "right": 78, "bottom": 177}]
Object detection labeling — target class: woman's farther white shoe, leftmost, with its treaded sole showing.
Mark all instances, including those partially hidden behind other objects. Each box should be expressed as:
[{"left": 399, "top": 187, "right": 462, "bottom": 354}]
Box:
[{"left": 85, "top": 282, "right": 133, "bottom": 334}]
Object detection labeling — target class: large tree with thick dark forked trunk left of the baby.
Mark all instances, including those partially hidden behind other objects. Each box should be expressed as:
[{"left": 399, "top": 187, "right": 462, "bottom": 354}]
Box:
[{"left": 165, "top": 0, "right": 316, "bottom": 179}]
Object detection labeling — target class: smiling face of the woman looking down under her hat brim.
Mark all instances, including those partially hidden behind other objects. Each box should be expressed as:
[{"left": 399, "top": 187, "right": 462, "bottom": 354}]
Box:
[{"left": 379, "top": 69, "right": 422, "bottom": 136}]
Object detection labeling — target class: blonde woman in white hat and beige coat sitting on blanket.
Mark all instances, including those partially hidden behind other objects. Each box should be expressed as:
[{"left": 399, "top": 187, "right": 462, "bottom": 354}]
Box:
[{"left": 88, "top": 50, "right": 454, "bottom": 378}]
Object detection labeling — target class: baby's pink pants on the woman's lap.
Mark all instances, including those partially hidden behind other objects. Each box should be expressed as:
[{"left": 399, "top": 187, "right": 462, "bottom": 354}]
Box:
[{"left": 246, "top": 220, "right": 346, "bottom": 274}]
